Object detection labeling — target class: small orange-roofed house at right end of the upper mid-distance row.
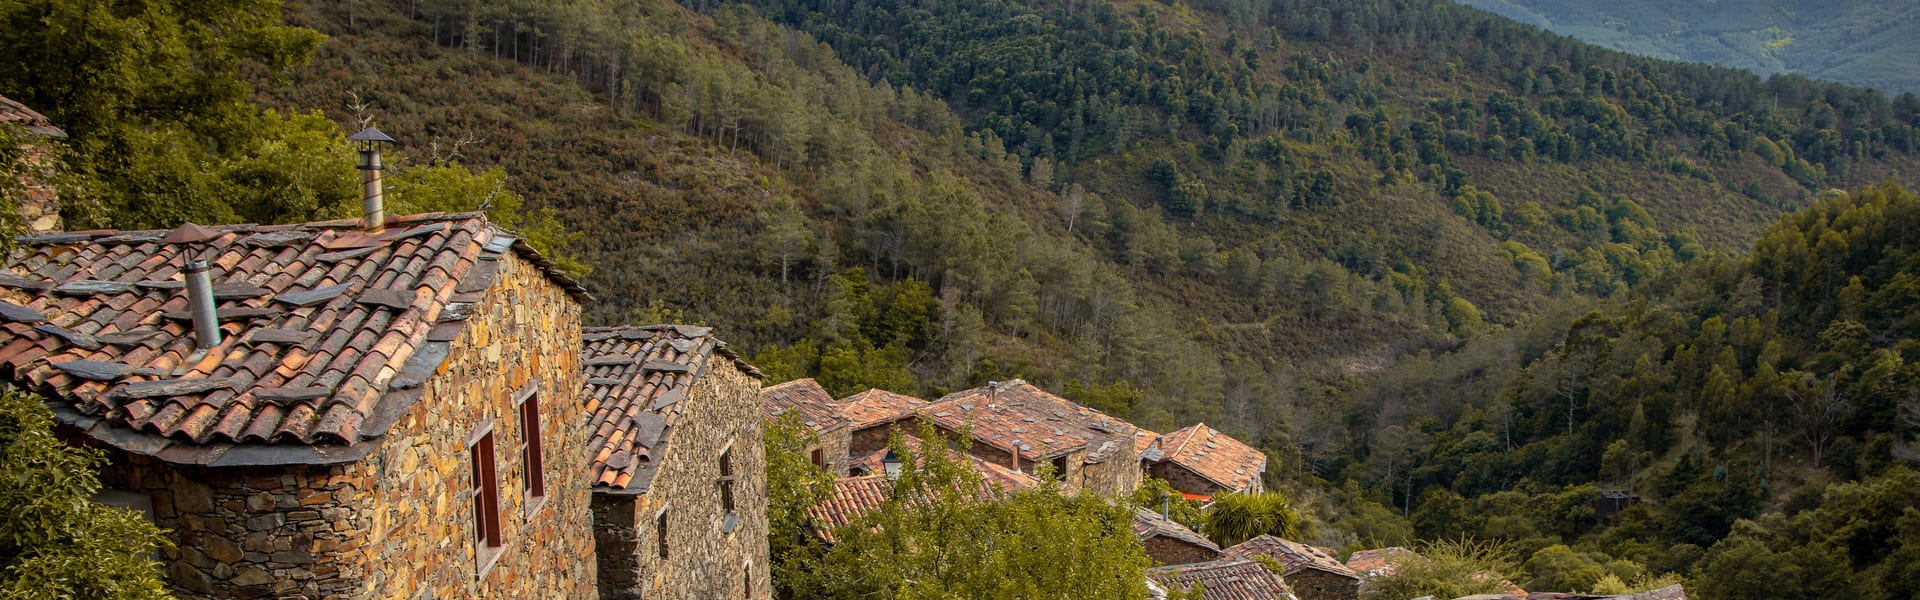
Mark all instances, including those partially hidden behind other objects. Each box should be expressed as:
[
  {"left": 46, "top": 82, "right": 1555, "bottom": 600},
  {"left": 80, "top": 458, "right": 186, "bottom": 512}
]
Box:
[{"left": 1142, "top": 423, "right": 1267, "bottom": 496}]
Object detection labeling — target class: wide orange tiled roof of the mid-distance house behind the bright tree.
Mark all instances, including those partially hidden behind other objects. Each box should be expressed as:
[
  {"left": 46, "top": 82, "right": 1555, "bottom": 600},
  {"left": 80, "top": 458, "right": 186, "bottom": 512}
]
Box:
[{"left": 920, "top": 379, "right": 1139, "bottom": 463}]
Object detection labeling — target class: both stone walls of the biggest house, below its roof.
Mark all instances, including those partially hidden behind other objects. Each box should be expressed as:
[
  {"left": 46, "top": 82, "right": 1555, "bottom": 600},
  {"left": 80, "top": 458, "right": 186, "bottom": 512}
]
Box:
[{"left": 88, "top": 254, "right": 591, "bottom": 600}]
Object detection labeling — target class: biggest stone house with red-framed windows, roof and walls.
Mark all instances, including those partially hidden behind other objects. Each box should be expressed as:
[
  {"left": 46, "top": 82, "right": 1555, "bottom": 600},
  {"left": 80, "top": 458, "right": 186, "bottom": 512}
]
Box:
[{"left": 0, "top": 213, "right": 595, "bottom": 598}]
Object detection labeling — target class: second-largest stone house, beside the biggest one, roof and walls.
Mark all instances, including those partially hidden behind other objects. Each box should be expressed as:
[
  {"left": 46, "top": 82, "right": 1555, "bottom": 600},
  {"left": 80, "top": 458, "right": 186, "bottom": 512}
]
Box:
[{"left": 579, "top": 325, "right": 772, "bottom": 600}]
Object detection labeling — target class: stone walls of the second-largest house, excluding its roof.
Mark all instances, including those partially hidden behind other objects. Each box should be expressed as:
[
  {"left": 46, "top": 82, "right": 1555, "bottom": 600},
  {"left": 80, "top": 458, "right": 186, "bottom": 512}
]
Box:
[{"left": 593, "top": 354, "right": 768, "bottom": 600}]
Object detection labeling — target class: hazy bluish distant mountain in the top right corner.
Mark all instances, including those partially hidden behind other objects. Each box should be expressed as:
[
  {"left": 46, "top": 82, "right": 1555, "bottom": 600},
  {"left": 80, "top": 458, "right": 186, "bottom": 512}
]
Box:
[{"left": 1459, "top": 0, "right": 1920, "bottom": 94}]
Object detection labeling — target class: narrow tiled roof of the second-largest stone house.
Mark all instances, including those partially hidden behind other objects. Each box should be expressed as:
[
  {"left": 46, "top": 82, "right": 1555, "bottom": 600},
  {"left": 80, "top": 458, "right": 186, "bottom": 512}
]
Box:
[{"left": 580, "top": 325, "right": 760, "bottom": 494}]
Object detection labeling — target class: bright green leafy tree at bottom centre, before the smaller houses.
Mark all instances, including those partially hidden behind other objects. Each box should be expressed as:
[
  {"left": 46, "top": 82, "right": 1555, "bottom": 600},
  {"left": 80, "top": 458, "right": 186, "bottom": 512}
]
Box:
[{"left": 783, "top": 427, "right": 1148, "bottom": 600}]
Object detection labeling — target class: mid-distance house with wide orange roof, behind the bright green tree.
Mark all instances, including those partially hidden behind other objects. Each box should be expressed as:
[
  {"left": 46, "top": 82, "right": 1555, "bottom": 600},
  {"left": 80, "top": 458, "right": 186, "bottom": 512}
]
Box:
[{"left": 916, "top": 379, "right": 1140, "bottom": 494}]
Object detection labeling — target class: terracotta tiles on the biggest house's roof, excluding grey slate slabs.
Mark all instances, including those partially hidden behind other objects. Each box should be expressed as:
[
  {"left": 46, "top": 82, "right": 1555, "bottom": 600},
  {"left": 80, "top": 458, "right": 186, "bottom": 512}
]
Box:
[{"left": 0, "top": 213, "right": 586, "bottom": 463}]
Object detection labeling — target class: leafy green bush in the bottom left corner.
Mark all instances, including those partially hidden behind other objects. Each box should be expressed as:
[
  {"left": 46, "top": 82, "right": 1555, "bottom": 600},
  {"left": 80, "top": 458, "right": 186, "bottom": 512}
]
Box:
[{"left": 0, "top": 388, "right": 169, "bottom": 600}]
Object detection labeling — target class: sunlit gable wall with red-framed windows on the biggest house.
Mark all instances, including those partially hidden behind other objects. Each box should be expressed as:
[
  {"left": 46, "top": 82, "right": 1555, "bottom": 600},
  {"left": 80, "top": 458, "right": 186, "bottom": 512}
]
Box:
[{"left": 357, "top": 252, "right": 595, "bottom": 598}]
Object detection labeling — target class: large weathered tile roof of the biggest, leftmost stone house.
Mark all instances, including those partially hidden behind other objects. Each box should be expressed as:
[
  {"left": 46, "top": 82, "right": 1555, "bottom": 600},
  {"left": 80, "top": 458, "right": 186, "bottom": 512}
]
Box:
[{"left": 0, "top": 213, "right": 589, "bottom": 465}]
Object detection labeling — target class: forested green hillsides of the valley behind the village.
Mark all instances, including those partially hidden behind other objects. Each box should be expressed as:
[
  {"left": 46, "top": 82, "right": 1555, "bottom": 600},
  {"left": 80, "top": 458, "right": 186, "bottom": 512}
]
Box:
[{"left": 0, "top": 0, "right": 1920, "bottom": 600}]
